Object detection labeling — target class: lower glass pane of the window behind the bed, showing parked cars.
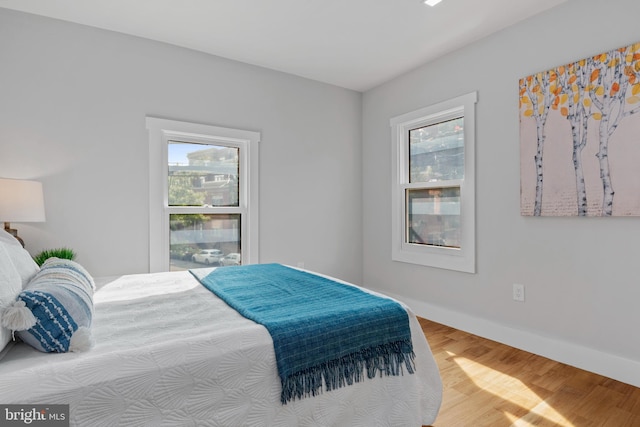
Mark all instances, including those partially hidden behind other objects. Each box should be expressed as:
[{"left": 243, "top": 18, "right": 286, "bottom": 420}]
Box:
[{"left": 169, "top": 214, "right": 242, "bottom": 271}]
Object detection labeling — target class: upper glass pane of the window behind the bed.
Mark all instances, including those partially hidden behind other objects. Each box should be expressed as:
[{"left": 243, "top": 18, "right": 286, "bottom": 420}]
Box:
[{"left": 168, "top": 141, "right": 240, "bottom": 206}]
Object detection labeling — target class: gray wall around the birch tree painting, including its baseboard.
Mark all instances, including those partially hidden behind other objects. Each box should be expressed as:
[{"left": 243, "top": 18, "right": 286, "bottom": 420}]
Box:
[{"left": 363, "top": 0, "right": 640, "bottom": 385}]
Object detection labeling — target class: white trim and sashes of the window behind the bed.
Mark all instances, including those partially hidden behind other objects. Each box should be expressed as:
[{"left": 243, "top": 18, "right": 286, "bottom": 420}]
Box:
[{"left": 146, "top": 117, "right": 261, "bottom": 273}]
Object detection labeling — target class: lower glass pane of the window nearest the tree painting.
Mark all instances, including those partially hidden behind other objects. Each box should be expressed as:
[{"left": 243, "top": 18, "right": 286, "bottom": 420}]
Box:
[{"left": 406, "top": 187, "right": 460, "bottom": 248}]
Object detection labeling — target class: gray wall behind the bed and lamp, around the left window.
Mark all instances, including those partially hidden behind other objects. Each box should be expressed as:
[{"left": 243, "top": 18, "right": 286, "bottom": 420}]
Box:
[{"left": 0, "top": 9, "right": 362, "bottom": 282}]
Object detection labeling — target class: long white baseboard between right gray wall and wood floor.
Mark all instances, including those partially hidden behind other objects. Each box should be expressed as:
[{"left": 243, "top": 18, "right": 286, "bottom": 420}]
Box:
[{"left": 382, "top": 291, "right": 640, "bottom": 387}]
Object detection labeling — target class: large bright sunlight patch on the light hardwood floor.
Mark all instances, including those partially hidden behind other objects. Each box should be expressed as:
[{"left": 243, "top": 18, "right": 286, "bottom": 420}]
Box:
[{"left": 451, "top": 354, "right": 575, "bottom": 427}]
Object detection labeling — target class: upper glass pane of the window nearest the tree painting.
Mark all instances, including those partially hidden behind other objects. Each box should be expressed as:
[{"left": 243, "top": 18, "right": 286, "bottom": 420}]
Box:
[{"left": 409, "top": 117, "right": 464, "bottom": 182}]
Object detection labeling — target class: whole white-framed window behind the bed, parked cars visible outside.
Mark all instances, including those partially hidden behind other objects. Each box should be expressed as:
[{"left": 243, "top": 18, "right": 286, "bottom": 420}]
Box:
[{"left": 147, "top": 117, "right": 260, "bottom": 272}]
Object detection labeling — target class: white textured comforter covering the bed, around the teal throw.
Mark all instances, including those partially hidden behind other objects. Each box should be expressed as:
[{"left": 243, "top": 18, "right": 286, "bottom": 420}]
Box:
[{"left": 0, "top": 271, "right": 442, "bottom": 427}]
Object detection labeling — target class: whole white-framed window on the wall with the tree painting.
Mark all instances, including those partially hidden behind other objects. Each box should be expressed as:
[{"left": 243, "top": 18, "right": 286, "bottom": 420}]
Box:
[{"left": 391, "top": 92, "right": 477, "bottom": 273}]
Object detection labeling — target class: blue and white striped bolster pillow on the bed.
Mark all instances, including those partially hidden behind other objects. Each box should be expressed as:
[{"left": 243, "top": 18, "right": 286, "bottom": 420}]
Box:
[{"left": 15, "top": 258, "right": 95, "bottom": 353}]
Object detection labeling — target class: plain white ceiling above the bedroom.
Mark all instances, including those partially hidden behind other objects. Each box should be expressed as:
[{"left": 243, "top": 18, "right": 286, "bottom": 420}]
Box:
[{"left": 0, "top": 0, "right": 566, "bottom": 91}]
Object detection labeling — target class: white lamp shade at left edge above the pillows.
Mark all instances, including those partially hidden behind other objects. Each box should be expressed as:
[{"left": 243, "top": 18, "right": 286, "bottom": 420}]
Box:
[{"left": 0, "top": 178, "right": 45, "bottom": 222}]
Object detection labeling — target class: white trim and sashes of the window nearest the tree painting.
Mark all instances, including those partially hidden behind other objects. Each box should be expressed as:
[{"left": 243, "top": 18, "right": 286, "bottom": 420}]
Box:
[{"left": 390, "top": 92, "right": 478, "bottom": 273}]
